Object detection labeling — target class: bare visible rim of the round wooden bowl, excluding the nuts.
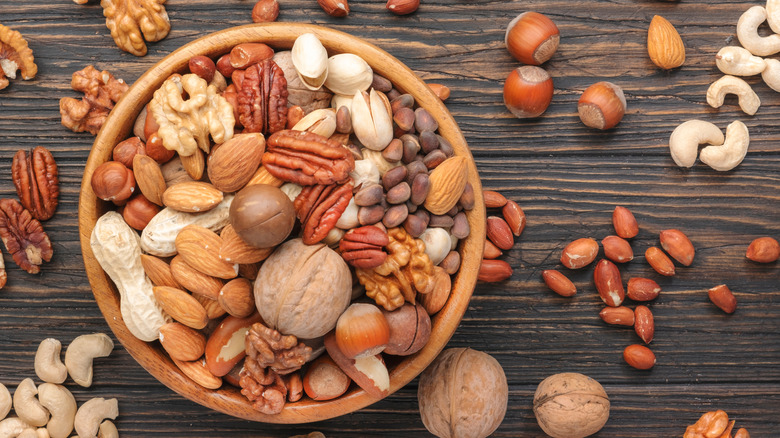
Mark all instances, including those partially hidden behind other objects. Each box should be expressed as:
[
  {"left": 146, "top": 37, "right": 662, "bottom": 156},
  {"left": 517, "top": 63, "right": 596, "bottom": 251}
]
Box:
[{"left": 79, "top": 23, "right": 485, "bottom": 423}]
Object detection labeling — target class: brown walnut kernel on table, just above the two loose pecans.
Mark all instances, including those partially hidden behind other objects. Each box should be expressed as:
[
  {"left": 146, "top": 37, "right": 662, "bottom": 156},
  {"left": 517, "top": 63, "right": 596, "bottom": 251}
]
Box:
[{"left": 60, "top": 65, "right": 129, "bottom": 135}]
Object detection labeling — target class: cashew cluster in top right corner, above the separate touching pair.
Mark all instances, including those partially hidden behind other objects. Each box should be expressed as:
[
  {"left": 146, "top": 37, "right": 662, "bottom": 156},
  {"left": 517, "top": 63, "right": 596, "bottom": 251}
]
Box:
[{"left": 707, "top": 0, "right": 780, "bottom": 116}]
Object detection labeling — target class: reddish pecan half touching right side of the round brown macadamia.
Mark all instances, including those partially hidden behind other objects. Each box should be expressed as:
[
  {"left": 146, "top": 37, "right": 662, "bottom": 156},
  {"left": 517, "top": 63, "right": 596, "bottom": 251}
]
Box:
[{"left": 293, "top": 181, "right": 352, "bottom": 245}]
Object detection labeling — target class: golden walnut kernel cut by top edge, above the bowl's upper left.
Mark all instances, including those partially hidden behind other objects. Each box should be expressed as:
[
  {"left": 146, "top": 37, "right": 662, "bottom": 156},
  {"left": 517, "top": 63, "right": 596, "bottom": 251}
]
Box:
[{"left": 100, "top": 0, "right": 171, "bottom": 56}]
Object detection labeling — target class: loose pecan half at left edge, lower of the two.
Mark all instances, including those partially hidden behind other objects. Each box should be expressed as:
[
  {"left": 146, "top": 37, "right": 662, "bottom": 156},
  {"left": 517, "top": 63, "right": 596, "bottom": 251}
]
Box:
[{"left": 0, "top": 199, "right": 54, "bottom": 274}]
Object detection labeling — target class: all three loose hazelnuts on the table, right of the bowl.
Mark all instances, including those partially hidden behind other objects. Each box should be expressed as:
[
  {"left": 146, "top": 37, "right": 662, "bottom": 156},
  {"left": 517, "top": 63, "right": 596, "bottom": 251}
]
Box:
[{"left": 504, "top": 12, "right": 626, "bottom": 130}]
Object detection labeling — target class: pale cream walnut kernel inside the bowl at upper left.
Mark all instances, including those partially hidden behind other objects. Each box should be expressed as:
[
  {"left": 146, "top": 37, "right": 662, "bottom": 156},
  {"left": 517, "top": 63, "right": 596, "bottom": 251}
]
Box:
[{"left": 148, "top": 74, "right": 235, "bottom": 157}]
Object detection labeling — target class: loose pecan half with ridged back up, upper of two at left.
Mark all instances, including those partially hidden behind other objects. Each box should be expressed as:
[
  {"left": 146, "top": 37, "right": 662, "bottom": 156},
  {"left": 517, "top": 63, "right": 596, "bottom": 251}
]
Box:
[{"left": 11, "top": 146, "right": 60, "bottom": 221}]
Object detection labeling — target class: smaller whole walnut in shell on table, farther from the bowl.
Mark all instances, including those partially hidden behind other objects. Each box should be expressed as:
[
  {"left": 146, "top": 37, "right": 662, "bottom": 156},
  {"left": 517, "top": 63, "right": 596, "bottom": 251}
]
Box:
[{"left": 534, "top": 373, "right": 609, "bottom": 438}]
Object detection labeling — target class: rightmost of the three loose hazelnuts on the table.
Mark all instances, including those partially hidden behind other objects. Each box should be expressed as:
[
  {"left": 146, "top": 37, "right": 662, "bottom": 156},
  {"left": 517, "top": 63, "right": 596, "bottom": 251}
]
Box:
[{"left": 577, "top": 82, "right": 626, "bottom": 130}]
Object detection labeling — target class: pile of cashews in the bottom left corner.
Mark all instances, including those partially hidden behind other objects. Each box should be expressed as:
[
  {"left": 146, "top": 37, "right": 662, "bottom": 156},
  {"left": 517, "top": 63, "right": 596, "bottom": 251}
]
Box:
[{"left": 0, "top": 333, "right": 119, "bottom": 438}]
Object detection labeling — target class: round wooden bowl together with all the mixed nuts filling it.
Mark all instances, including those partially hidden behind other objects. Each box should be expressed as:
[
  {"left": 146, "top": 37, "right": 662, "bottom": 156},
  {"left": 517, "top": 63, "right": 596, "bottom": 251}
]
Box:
[{"left": 79, "top": 23, "right": 485, "bottom": 423}]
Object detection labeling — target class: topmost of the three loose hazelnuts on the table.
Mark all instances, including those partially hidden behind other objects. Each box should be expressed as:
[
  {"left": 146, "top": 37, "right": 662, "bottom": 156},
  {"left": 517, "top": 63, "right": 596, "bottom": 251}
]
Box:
[{"left": 504, "top": 12, "right": 561, "bottom": 65}]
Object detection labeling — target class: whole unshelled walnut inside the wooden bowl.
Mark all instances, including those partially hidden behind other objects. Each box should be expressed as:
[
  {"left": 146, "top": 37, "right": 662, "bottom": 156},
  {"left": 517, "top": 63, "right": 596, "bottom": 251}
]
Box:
[{"left": 255, "top": 239, "right": 352, "bottom": 339}]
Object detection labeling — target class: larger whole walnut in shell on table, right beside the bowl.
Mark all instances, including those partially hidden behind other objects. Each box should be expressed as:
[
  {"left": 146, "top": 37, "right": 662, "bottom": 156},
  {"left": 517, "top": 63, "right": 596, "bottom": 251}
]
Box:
[{"left": 417, "top": 348, "right": 509, "bottom": 438}]
